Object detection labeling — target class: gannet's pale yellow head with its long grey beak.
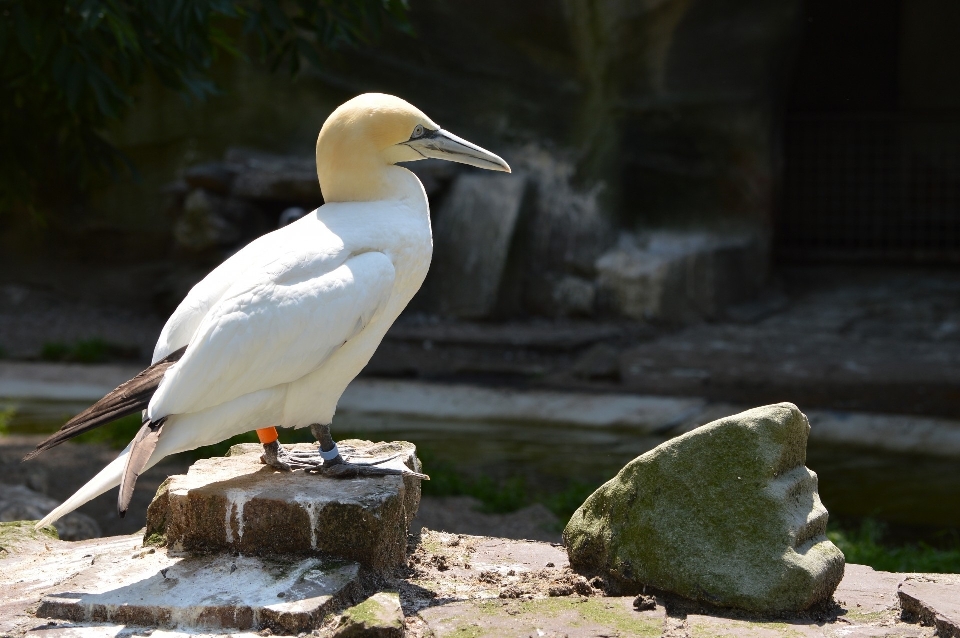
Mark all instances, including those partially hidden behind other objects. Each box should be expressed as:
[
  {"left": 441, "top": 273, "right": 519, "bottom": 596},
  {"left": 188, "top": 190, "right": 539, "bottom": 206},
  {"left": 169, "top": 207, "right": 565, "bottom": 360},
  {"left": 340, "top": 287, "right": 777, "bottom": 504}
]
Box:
[{"left": 317, "top": 93, "right": 510, "bottom": 202}]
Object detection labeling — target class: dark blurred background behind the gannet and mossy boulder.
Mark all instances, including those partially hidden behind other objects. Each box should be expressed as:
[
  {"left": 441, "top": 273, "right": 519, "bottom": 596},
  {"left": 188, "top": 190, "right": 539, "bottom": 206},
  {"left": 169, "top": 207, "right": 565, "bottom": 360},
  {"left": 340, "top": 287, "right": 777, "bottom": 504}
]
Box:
[{"left": 0, "top": 0, "right": 960, "bottom": 572}]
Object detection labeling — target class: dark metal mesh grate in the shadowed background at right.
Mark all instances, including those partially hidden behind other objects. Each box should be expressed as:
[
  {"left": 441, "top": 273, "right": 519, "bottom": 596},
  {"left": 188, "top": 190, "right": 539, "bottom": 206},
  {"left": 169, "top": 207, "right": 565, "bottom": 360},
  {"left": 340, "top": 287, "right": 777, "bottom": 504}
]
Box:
[{"left": 775, "top": 114, "right": 960, "bottom": 262}]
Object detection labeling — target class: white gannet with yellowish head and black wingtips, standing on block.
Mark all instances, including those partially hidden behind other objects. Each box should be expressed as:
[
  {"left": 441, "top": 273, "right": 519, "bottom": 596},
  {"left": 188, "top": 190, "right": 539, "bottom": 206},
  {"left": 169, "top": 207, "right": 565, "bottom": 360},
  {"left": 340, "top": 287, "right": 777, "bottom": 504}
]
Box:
[{"left": 26, "top": 93, "right": 510, "bottom": 527}]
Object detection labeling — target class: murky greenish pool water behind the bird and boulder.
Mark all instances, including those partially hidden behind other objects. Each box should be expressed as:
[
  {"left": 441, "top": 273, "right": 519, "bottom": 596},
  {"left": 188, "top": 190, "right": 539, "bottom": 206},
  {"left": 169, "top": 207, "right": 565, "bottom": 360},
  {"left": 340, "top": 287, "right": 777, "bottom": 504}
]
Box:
[{"left": 0, "top": 401, "right": 960, "bottom": 536}]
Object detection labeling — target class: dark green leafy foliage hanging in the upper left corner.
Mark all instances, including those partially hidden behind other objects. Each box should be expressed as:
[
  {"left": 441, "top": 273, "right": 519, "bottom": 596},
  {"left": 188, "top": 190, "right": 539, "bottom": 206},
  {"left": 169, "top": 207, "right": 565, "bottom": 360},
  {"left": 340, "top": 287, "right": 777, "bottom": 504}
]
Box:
[{"left": 0, "top": 0, "right": 408, "bottom": 224}]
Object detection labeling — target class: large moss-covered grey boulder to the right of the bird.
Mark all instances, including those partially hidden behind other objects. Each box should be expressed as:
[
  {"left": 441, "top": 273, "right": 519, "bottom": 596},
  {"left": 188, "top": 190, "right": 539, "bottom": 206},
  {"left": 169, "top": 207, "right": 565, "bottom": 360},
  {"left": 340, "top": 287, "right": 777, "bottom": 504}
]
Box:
[{"left": 563, "top": 403, "right": 844, "bottom": 612}]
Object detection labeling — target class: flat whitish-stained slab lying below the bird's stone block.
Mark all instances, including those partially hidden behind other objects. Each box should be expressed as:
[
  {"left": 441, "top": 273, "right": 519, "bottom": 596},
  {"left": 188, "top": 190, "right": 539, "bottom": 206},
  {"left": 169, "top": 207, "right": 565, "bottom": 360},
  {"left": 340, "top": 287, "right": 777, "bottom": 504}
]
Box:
[{"left": 37, "top": 550, "right": 360, "bottom": 633}]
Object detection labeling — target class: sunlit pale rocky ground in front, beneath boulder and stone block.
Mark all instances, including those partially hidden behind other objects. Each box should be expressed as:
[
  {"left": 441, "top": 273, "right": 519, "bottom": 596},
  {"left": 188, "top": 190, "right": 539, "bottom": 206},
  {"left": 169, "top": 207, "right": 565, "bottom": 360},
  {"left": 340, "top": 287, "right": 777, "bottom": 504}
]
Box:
[{"left": 0, "top": 524, "right": 960, "bottom": 638}]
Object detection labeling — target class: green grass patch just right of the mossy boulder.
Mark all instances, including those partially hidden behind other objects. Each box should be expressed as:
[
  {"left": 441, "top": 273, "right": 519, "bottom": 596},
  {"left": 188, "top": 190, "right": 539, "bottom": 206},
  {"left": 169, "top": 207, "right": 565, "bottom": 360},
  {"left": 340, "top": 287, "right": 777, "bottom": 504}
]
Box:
[{"left": 827, "top": 518, "right": 960, "bottom": 573}]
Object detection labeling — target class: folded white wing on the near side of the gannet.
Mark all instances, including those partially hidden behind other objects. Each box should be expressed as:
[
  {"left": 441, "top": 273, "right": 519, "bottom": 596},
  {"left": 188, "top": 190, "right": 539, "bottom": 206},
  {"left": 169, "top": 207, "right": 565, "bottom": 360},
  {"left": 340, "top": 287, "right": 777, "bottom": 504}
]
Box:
[{"left": 147, "top": 252, "right": 395, "bottom": 420}]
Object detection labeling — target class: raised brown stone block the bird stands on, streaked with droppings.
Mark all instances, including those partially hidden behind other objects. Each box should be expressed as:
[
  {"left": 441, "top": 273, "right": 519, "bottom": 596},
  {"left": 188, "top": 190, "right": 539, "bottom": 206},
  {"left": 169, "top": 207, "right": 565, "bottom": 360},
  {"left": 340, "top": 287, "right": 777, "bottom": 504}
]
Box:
[{"left": 144, "top": 441, "right": 420, "bottom": 570}]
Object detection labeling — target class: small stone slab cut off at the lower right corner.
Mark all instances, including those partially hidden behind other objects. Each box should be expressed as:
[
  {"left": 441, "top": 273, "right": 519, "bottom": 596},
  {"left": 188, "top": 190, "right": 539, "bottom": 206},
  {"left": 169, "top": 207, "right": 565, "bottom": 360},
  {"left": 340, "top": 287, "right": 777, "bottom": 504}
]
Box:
[{"left": 897, "top": 574, "right": 960, "bottom": 638}]
